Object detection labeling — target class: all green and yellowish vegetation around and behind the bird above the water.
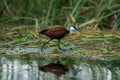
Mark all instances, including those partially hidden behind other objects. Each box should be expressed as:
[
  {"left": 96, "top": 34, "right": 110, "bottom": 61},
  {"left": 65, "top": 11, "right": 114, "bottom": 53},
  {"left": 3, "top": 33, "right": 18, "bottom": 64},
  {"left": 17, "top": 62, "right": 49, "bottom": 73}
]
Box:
[{"left": 0, "top": 0, "right": 120, "bottom": 56}]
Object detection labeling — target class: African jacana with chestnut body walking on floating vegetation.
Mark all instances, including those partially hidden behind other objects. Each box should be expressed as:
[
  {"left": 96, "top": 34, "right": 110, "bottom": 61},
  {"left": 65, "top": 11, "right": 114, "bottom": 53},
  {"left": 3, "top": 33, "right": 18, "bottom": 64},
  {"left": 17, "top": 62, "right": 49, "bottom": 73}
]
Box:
[{"left": 39, "top": 26, "right": 80, "bottom": 51}]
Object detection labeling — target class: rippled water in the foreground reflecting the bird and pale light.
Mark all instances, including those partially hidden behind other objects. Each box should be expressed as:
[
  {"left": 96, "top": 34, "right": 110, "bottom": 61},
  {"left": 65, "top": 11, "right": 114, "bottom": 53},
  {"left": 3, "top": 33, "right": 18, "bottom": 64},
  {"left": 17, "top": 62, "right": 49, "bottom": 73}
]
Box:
[{"left": 0, "top": 55, "right": 120, "bottom": 80}]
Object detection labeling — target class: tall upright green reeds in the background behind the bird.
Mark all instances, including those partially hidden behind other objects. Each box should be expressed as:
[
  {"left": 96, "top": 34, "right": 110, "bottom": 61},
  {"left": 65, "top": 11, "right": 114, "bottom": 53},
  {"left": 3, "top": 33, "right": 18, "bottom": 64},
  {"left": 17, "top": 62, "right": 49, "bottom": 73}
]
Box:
[{"left": 0, "top": 0, "right": 120, "bottom": 29}]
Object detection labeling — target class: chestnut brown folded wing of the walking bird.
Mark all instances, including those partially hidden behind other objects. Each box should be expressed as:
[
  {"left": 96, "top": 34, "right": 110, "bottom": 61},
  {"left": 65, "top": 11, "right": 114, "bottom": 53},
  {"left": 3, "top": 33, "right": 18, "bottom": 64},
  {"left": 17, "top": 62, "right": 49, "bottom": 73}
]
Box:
[{"left": 45, "top": 27, "right": 68, "bottom": 39}]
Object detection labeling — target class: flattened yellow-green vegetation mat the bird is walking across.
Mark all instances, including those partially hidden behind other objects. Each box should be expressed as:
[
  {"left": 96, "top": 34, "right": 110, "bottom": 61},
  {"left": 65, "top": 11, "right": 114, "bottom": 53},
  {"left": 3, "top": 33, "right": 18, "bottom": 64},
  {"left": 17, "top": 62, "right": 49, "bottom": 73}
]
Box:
[{"left": 0, "top": 26, "right": 120, "bottom": 57}]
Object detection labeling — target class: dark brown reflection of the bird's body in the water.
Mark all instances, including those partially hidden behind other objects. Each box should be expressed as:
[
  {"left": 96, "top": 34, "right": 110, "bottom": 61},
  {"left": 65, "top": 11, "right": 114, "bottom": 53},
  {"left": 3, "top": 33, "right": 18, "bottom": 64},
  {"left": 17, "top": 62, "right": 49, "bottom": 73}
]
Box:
[{"left": 39, "top": 61, "right": 69, "bottom": 76}]
